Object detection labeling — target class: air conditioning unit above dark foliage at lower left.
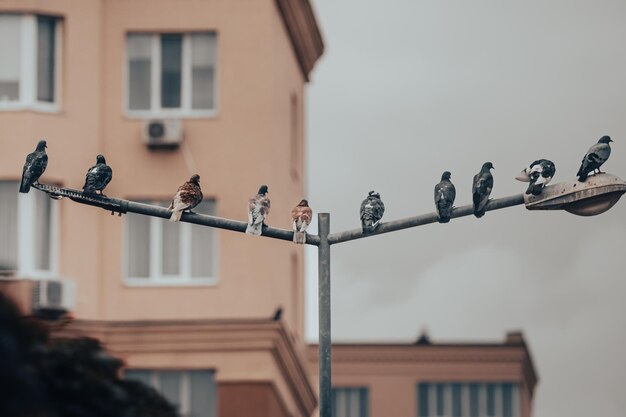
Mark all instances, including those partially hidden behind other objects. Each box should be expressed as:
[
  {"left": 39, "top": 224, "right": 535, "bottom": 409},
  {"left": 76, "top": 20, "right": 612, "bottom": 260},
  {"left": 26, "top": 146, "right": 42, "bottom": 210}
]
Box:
[{"left": 32, "top": 280, "right": 76, "bottom": 318}]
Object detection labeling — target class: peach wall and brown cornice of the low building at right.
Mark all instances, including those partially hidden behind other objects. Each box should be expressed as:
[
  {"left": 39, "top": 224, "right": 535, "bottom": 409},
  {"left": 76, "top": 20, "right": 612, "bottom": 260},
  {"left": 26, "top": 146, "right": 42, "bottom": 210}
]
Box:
[{"left": 308, "top": 342, "right": 536, "bottom": 417}]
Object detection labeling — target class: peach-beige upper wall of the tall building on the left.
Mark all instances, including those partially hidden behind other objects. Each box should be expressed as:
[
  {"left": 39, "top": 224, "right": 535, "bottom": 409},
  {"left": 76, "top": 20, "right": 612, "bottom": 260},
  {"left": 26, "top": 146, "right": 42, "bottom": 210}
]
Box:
[{"left": 0, "top": 0, "right": 305, "bottom": 336}]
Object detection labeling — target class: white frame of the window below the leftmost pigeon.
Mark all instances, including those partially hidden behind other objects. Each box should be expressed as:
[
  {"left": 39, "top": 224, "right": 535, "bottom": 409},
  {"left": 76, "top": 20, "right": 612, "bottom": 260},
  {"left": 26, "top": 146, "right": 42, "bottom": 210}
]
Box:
[{"left": 0, "top": 180, "right": 60, "bottom": 280}]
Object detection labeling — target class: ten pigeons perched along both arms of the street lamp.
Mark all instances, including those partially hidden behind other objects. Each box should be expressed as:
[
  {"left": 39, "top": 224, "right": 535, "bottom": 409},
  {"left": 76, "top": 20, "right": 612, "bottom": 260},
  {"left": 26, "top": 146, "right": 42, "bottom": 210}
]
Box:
[{"left": 20, "top": 136, "right": 612, "bottom": 244}]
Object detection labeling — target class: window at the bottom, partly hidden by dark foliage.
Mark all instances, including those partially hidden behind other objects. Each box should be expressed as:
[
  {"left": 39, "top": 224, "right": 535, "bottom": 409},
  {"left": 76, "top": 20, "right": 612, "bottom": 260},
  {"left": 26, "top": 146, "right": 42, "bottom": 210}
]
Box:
[{"left": 125, "top": 369, "right": 217, "bottom": 417}]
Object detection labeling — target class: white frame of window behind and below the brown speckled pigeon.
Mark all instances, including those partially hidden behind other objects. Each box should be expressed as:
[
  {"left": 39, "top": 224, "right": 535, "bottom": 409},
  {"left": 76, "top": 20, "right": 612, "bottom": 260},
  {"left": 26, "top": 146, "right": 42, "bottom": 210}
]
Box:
[{"left": 122, "top": 198, "right": 219, "bottom": 287}]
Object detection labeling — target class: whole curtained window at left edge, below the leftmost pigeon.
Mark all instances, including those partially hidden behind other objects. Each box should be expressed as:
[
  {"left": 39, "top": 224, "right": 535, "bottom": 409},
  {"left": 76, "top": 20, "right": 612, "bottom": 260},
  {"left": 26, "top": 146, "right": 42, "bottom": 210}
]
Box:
[{"left": 0, "top": 181, "right": 57, "bottom": 278}]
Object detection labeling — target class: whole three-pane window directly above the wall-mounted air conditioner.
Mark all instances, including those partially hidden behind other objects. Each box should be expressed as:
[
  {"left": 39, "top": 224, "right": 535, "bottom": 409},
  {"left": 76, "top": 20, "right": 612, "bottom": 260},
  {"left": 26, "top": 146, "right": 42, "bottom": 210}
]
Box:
[{"left": 126, "top": 32, "right": 216, "bottom": 117}]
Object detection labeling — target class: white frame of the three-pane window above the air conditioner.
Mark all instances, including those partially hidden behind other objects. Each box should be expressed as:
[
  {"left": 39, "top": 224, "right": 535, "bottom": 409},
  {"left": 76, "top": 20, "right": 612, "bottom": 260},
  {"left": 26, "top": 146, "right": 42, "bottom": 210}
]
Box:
[{"left": 122, "top": 29, "right": 219, "bottom": 119}]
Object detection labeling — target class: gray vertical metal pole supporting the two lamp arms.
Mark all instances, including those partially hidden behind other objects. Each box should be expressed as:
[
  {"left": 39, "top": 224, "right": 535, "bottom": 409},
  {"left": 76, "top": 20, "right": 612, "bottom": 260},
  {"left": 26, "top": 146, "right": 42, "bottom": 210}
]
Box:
[{"left": 317, "top": 213, "right": 332, "bottom": 417}]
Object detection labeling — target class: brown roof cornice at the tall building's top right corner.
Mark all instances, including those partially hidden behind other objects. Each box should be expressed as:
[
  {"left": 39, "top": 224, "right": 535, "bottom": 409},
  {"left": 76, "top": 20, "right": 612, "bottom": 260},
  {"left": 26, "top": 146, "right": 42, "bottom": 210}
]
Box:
[{"left": 276, "top": 0, "right": 324, "bottom": 81}]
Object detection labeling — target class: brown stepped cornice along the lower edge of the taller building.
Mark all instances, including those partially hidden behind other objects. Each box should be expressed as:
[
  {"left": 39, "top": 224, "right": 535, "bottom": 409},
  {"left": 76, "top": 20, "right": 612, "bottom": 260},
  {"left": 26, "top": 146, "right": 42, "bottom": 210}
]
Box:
[{"left": 55, "top": 319, "right": 317, "bottom": 415}]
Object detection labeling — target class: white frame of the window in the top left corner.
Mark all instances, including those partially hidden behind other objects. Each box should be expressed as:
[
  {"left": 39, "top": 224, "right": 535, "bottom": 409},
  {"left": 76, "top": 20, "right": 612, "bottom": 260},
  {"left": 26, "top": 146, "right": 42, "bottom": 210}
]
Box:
[{"left": 0, "top": 13, "right": 63, "bottom": 113}]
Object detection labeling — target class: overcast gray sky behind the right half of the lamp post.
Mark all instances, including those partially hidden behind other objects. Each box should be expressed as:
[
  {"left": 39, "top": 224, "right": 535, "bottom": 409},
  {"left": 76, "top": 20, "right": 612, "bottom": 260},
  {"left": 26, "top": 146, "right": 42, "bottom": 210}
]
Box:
[{"left": 307, "top": 0, "right": 626, "bottom": 417}]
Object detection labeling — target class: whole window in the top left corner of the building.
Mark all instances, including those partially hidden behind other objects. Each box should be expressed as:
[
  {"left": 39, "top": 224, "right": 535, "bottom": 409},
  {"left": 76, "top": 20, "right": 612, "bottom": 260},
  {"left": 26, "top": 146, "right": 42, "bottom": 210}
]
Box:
[{"left": 0, "top": 14, "right": 61, "bottom": 111}]
